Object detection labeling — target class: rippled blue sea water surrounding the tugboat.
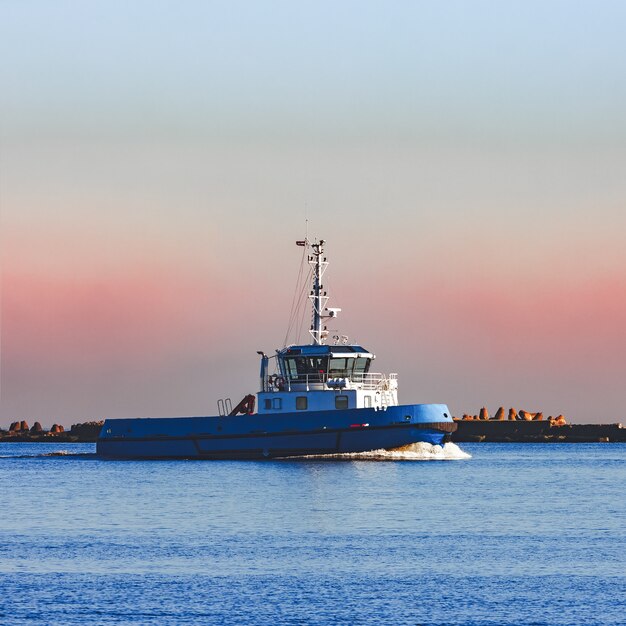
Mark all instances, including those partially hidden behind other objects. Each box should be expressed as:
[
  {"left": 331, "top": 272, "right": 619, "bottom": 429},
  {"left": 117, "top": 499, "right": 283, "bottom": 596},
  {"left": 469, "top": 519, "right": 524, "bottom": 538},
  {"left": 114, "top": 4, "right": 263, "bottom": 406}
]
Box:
[{"left": 0, "top": 443, "right": 626, "bottom": 625}]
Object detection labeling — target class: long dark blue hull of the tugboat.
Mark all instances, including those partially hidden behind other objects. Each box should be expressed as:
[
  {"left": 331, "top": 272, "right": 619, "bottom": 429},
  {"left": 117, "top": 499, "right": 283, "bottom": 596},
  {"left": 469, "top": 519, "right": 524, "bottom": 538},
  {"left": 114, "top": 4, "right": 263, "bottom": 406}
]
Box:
[{"left": 97, "top": 404, "right": 456, "bottom": 459}]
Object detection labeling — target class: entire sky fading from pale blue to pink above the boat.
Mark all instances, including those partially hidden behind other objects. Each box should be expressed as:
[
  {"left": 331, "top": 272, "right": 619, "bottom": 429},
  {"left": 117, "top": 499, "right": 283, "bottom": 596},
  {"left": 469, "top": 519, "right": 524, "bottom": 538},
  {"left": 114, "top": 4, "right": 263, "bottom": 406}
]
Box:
[{"left": 0, "top": 0, "right": 626, "bottom": 428}]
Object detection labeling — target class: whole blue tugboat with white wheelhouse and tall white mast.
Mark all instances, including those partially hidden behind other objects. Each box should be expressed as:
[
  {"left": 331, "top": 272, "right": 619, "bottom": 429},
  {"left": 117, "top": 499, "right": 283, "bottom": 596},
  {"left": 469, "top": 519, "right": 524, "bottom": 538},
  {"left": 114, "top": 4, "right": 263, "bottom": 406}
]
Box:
[{"left": 96, "top": 238, "right": 456, "bottom": 459}]
